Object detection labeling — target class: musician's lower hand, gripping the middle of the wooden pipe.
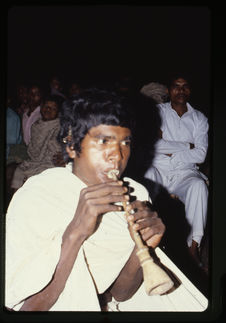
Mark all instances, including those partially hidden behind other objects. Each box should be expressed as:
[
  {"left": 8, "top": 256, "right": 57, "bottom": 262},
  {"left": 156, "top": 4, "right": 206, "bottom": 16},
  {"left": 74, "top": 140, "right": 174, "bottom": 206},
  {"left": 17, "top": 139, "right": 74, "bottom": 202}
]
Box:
[{"left": 126, "top": 201, "right": 165, "bottom": 248}]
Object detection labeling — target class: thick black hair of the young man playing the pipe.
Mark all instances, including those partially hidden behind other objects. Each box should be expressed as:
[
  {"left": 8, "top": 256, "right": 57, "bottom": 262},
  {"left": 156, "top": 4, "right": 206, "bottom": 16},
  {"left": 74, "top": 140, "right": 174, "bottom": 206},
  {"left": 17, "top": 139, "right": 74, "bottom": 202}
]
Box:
[{"left": 58, "top": 88, "right": 134, "bottom": 162}]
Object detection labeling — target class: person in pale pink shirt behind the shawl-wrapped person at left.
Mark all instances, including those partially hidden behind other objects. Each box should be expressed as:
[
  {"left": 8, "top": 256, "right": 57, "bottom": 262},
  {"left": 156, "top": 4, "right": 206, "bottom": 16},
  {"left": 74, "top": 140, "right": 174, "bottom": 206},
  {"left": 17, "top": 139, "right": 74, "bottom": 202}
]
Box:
[{"left": 22, "top": 85, "right": 42, "bottom": 146}]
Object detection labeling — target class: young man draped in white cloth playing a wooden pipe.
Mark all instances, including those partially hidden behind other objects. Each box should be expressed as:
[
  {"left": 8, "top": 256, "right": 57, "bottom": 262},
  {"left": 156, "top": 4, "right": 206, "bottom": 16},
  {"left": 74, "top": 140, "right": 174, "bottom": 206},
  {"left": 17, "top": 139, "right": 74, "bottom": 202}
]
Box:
[{"left": 5, "top": 89, "right": 207, "bottom": 315}]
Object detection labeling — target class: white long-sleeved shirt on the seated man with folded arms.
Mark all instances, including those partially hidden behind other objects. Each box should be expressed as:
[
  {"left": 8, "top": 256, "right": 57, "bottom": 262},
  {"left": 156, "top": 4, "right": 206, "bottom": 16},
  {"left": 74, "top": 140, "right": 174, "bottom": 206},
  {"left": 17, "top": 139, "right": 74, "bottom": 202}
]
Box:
[{"left": 153, "top": 102, "right": 209, "bottom": 175}]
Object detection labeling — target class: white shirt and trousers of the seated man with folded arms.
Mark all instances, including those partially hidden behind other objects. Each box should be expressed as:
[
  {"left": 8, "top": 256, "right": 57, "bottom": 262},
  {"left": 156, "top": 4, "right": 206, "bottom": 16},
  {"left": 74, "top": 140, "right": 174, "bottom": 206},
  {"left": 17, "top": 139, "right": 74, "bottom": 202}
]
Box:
[{"left": 144, "top": 102, "right": 209, "bottom": 246}]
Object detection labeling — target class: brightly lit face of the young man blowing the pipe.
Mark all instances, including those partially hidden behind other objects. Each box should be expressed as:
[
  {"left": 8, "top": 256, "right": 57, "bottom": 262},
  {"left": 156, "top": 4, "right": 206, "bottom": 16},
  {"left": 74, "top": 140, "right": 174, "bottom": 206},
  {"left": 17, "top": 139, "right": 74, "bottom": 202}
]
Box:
[{"left": 69, "top": 125, "right": 131, "bottom": 185}]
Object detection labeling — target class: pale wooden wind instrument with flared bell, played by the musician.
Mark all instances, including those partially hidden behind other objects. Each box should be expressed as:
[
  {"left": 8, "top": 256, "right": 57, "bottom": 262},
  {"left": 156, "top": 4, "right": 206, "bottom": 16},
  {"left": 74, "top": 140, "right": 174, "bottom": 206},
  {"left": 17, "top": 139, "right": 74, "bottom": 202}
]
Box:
[{"left": 108, "top": 169, "right": 174, "bottom": 296}]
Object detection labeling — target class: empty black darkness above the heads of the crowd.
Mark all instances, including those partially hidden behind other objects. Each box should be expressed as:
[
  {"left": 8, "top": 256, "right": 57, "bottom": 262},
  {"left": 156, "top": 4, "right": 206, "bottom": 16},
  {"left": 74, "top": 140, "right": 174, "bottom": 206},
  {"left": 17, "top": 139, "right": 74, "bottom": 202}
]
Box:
[{"left": 7, "top": 4, "right": 213, "bottom": 114}]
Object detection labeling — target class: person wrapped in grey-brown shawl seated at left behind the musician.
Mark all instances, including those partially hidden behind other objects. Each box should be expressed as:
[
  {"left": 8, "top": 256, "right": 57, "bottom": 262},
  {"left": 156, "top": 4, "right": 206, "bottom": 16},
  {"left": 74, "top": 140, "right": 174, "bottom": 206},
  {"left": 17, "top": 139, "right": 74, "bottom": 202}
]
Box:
[{"left": 11, "top": 96, "right": 61, "bottom": 190}]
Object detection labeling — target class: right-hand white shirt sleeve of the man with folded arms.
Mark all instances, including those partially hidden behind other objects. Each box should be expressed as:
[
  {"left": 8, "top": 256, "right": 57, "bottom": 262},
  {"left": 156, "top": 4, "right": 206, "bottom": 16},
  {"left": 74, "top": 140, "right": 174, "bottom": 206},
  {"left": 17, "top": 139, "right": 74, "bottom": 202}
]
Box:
[{"left": 171, "top": 115, "right": 209, "bottom": 164}]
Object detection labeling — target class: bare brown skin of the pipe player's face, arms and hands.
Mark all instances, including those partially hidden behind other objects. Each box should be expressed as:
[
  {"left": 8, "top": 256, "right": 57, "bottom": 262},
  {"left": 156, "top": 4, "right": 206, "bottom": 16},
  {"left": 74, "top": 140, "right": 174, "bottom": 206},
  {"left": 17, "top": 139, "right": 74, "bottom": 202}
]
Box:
[{"left": 21, "top": 125, "right": 165, "bottom": 311}]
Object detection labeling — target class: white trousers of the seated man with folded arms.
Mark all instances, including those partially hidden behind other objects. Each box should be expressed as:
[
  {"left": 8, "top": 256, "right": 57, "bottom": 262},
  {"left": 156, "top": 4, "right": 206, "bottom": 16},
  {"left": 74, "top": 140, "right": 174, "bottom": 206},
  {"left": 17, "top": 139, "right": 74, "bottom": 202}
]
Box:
[{"left": 145, "top": 166, "right": 208, "bottom": 247}]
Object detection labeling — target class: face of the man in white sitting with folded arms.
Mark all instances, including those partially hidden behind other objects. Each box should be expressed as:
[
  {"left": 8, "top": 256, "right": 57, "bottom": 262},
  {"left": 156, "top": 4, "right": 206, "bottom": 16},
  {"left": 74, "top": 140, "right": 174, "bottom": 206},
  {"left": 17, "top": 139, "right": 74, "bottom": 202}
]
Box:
[{"left": 169, "top": 78, "right": 191, "bottom": 104}]
